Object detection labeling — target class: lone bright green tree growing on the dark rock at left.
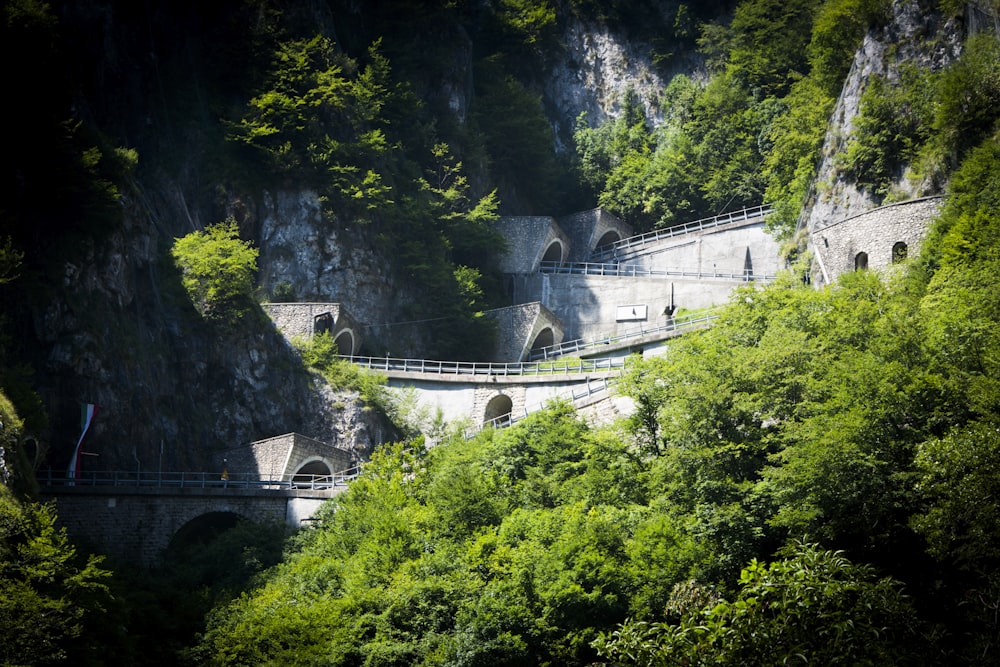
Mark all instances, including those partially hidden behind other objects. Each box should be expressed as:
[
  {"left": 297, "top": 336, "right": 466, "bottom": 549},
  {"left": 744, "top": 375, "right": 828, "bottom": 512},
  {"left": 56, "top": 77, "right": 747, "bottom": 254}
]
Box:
[{"left": 171, "top": 218, "right": 258, "bottom": 323}]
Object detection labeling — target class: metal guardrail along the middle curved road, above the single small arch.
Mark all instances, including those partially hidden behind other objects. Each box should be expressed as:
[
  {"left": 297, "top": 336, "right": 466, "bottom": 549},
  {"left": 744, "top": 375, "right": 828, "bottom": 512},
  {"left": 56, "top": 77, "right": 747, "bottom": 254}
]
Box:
[{"left": 339, "top": 355, "right": 625, "bottom": 377}]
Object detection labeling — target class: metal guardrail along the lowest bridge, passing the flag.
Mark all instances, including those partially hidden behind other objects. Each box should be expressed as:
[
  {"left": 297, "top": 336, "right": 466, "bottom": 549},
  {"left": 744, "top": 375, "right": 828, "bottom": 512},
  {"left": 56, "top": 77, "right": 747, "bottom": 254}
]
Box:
[{"left": 44, "top": 466, "right": 361, "bottom": 490}]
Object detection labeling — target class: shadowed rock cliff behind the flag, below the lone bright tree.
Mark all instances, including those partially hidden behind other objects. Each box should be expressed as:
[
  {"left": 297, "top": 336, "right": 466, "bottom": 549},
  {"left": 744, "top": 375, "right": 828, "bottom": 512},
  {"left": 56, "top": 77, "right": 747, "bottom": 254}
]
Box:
[{"left": 33, "top": 177, "right": 393, "bottom": 471}]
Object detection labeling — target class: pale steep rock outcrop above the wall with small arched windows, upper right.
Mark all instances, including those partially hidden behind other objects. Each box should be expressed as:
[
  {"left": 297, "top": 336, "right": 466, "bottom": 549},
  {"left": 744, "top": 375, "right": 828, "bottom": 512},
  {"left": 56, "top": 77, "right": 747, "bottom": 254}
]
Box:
[{"left": 802, "top": 0, "right": 961, "bottom": 231}]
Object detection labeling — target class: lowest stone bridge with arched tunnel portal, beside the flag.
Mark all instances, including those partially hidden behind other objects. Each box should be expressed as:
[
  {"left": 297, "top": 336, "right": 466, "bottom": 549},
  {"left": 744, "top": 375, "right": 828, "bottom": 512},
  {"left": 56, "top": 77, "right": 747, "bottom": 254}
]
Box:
[{"left": 39, "top": 433, "right": 358, "bottom": 567}]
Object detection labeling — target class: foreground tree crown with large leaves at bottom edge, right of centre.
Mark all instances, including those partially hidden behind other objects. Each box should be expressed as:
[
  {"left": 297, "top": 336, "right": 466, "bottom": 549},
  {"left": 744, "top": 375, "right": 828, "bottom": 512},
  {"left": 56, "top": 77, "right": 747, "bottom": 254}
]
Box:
[{"left": 596, "top": 544, "right": 921, "bottom": 666}]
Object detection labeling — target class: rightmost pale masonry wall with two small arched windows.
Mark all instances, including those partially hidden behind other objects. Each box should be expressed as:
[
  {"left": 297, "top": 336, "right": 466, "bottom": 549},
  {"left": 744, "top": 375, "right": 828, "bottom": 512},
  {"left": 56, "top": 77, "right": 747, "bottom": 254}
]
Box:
[{"left": 809, "top": 197, "right": 943, "bottom": 285}]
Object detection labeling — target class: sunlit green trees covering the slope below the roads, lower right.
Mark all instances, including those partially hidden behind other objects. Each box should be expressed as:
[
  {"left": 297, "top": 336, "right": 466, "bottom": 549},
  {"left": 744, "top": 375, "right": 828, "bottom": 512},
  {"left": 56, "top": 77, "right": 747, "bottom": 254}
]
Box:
[{"left": 192, "top": 136, "right": 1000, "bottom": 665}]
